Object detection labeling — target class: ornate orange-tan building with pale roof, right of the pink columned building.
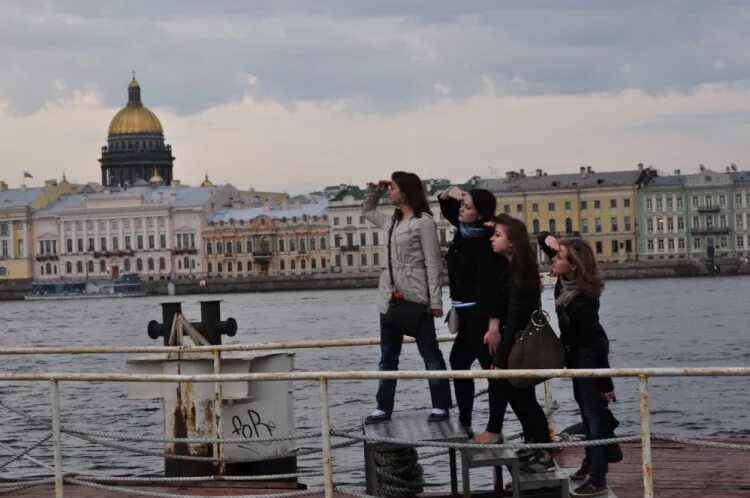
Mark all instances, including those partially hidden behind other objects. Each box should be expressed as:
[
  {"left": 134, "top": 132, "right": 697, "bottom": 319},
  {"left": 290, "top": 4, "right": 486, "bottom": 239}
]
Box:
[{"left": 203, "top": 196, "right": 330, "bottom": 278}]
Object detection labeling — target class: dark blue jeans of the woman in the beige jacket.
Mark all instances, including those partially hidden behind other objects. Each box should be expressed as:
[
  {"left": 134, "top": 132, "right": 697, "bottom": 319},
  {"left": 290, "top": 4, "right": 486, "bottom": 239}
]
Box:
[{"left": 376, "top": 314, "right": 452, "bottom": 413}]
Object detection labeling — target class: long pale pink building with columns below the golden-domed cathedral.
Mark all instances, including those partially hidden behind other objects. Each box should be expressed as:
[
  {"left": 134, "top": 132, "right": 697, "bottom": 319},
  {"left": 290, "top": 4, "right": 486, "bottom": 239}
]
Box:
[{"left": 32, "top": 182, "right": 239, "bottom": 281}]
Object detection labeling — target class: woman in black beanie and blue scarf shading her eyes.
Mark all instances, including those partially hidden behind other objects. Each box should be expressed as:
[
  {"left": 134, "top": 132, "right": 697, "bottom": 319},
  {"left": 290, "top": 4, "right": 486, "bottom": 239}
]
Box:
[{"left": 439, "top": 187, "right": 505, "bottom": 443}]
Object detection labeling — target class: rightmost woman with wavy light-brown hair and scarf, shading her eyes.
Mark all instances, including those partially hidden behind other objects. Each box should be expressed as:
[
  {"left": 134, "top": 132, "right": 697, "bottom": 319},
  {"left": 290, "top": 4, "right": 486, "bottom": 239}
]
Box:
[{"left": 538, "top": 232, "right": 622, "bottom": 496}]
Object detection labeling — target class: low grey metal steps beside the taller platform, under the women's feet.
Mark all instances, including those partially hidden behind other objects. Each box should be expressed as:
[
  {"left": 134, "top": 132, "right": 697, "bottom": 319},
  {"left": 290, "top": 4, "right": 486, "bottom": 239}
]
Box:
[{"left": 461, "top": 447, "right": 570, "bottom": 498}]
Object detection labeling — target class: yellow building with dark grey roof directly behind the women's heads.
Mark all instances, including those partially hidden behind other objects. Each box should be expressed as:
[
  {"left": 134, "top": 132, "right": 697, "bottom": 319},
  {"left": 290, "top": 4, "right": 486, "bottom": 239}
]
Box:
[{"left": 481, "top": 166, "right": 653, "bottom": 262}]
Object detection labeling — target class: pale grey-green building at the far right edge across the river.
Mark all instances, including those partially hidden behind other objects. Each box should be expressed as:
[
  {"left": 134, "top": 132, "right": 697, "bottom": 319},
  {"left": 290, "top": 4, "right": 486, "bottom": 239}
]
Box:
[{"left": 638, "top": 166, "right": 750, "bottom": 262}]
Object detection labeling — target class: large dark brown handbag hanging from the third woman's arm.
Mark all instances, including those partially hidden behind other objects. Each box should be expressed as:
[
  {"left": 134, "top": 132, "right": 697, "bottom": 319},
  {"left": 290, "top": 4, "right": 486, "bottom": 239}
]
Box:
[{"left": 508, "top": 309, "right": 565, "bottom": 388}]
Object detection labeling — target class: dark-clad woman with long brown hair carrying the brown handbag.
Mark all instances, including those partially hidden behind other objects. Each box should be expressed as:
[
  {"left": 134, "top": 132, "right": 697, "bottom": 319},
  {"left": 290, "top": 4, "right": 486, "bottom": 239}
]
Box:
[{"left": 490, "top": 214, "right": 555, "bottom": 472}]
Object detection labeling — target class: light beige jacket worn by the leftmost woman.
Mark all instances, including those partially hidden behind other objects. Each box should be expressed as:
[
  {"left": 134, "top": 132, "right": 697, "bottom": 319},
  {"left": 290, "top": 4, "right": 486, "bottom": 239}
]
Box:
[{"left": 362, "top": 186, "right": 443, "bottom": 313}]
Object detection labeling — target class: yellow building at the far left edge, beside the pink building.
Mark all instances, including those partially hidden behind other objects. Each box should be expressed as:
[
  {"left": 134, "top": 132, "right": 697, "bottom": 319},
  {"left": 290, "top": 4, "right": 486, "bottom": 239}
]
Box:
[{"left": 0, "top": 175, "right": 79, "bottom": 281}]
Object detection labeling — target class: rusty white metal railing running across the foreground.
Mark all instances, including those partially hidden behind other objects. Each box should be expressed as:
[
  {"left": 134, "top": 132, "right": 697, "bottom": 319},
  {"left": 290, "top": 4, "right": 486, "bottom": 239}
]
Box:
[{"left": 0, "top": 336, "right": 750, "bottom": 498}]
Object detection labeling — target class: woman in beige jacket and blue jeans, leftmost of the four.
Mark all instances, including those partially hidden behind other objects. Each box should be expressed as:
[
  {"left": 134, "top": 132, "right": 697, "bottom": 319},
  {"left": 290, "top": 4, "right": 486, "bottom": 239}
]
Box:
[{"left": 362, "top": 171, "right": 451, "bottom": 424}]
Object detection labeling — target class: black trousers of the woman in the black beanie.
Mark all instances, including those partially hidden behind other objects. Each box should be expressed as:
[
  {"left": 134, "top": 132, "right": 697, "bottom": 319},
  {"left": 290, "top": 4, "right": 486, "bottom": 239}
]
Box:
[{"left": 450, "top": 307, "right": 508, "bottom": 433}]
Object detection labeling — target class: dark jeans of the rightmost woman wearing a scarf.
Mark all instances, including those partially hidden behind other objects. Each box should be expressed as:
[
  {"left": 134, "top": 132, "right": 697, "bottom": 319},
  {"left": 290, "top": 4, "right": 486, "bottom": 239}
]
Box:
[{"left": 566, "top": 337, "right": 612, "bottom": 484}]
